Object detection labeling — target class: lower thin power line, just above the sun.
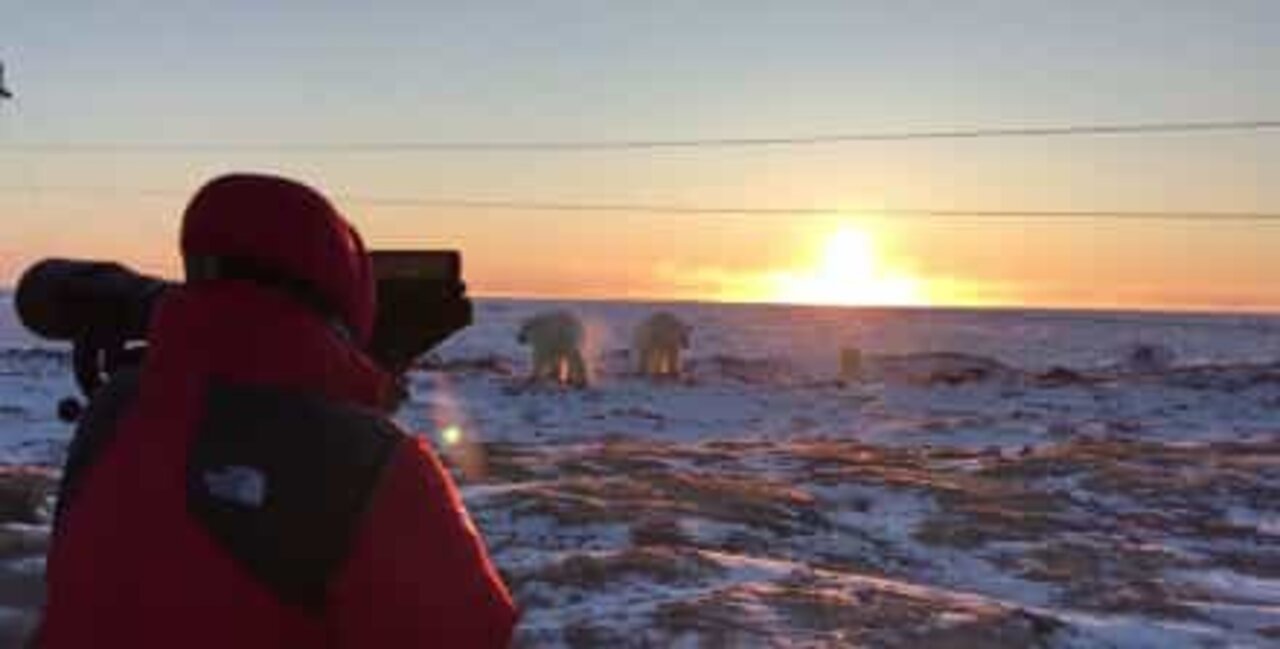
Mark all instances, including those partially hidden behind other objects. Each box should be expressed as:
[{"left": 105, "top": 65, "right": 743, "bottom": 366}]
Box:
[{"left": 0, "top": 186, "right": 1280, "bottom": 221}]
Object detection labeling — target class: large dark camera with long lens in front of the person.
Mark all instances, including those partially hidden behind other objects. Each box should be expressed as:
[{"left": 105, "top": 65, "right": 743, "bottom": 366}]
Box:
[{"left": 14, "top": 251, "right": 472, "bottom": 420}]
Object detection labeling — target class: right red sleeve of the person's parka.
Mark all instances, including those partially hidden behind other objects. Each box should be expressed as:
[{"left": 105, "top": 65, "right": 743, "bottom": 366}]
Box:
[{"left": 329, "top": 442, "right": 517, "bottom": 649}]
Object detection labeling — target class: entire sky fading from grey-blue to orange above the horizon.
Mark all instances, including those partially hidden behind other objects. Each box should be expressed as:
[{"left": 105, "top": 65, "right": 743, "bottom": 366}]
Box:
[{"left": 0, "top": 0, "right": 1280, "bottom": 311}]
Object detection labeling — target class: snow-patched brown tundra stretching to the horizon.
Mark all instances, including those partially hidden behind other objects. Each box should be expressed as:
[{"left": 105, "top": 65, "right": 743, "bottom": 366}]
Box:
[{"left": 0, "top": 297, "right": 1280, "bottom": 648}]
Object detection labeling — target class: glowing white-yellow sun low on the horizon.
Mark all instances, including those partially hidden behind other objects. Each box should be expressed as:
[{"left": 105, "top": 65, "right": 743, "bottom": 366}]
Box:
[{"left": 774, "top": 224, "right": 927, "bottom": 306}]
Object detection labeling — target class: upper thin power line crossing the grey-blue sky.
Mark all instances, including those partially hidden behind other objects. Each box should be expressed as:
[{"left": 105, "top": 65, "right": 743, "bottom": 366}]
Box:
[{"left": 0, "top": 119, "right": 1280, "bottom": 155}]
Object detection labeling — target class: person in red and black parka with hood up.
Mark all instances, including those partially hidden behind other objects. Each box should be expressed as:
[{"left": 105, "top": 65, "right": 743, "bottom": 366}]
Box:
[{"left": 35, "top": 174, "right": 517, "bottom": 649}]
